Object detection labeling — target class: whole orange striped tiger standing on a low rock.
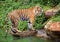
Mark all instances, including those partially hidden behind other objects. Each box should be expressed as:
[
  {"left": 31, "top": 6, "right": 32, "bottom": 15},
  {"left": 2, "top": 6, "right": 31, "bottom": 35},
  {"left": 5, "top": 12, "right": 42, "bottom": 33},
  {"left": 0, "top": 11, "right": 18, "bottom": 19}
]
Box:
[{"left": 7, "top": 6, "right": 42, "bottom": 33}]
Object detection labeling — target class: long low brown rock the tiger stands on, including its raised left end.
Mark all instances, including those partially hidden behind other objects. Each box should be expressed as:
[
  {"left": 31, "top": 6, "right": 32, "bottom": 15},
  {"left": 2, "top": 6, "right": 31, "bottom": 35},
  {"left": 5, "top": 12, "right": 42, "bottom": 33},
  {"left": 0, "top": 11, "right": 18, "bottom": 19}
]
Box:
[{"left": 7, "top": 30, "right": 37, "bottom": 37}]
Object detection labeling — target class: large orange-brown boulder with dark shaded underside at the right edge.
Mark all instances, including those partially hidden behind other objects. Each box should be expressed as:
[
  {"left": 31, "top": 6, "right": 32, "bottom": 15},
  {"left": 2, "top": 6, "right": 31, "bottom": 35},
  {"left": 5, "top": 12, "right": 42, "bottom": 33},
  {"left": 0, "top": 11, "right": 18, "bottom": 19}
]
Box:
[{"left": 44, "top": 20, "right": 60, "bottom": 38}]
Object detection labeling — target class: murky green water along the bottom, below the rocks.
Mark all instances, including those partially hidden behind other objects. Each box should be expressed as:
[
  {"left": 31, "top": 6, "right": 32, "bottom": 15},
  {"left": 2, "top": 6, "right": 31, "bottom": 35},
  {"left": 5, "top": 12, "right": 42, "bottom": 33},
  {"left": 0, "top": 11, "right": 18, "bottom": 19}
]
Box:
[{"left": 0, "top": 29, "right": 56, "bottom": 42}]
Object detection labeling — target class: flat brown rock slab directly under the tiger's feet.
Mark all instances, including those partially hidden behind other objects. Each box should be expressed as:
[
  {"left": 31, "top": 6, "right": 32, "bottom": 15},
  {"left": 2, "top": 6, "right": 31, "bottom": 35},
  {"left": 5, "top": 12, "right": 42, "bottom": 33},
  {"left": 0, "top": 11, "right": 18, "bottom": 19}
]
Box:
[{"left": 12, "top": 30, "right": 37, "bottom": 37}]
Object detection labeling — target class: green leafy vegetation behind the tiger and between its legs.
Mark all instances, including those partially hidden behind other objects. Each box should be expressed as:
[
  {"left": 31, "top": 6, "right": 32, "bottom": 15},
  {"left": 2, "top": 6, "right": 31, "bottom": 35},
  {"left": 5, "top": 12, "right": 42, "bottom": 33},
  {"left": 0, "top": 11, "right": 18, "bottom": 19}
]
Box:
[{"left": 0, "top": 0, "right": 60, "bottom": 42}]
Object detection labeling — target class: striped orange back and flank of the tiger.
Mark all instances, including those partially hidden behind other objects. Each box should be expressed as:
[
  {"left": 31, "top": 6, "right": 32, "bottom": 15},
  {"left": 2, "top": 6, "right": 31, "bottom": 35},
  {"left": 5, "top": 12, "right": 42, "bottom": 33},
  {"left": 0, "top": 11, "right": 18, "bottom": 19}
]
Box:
[{"left": 8, "top": 9, "right": 35, "bottom": 20}]
